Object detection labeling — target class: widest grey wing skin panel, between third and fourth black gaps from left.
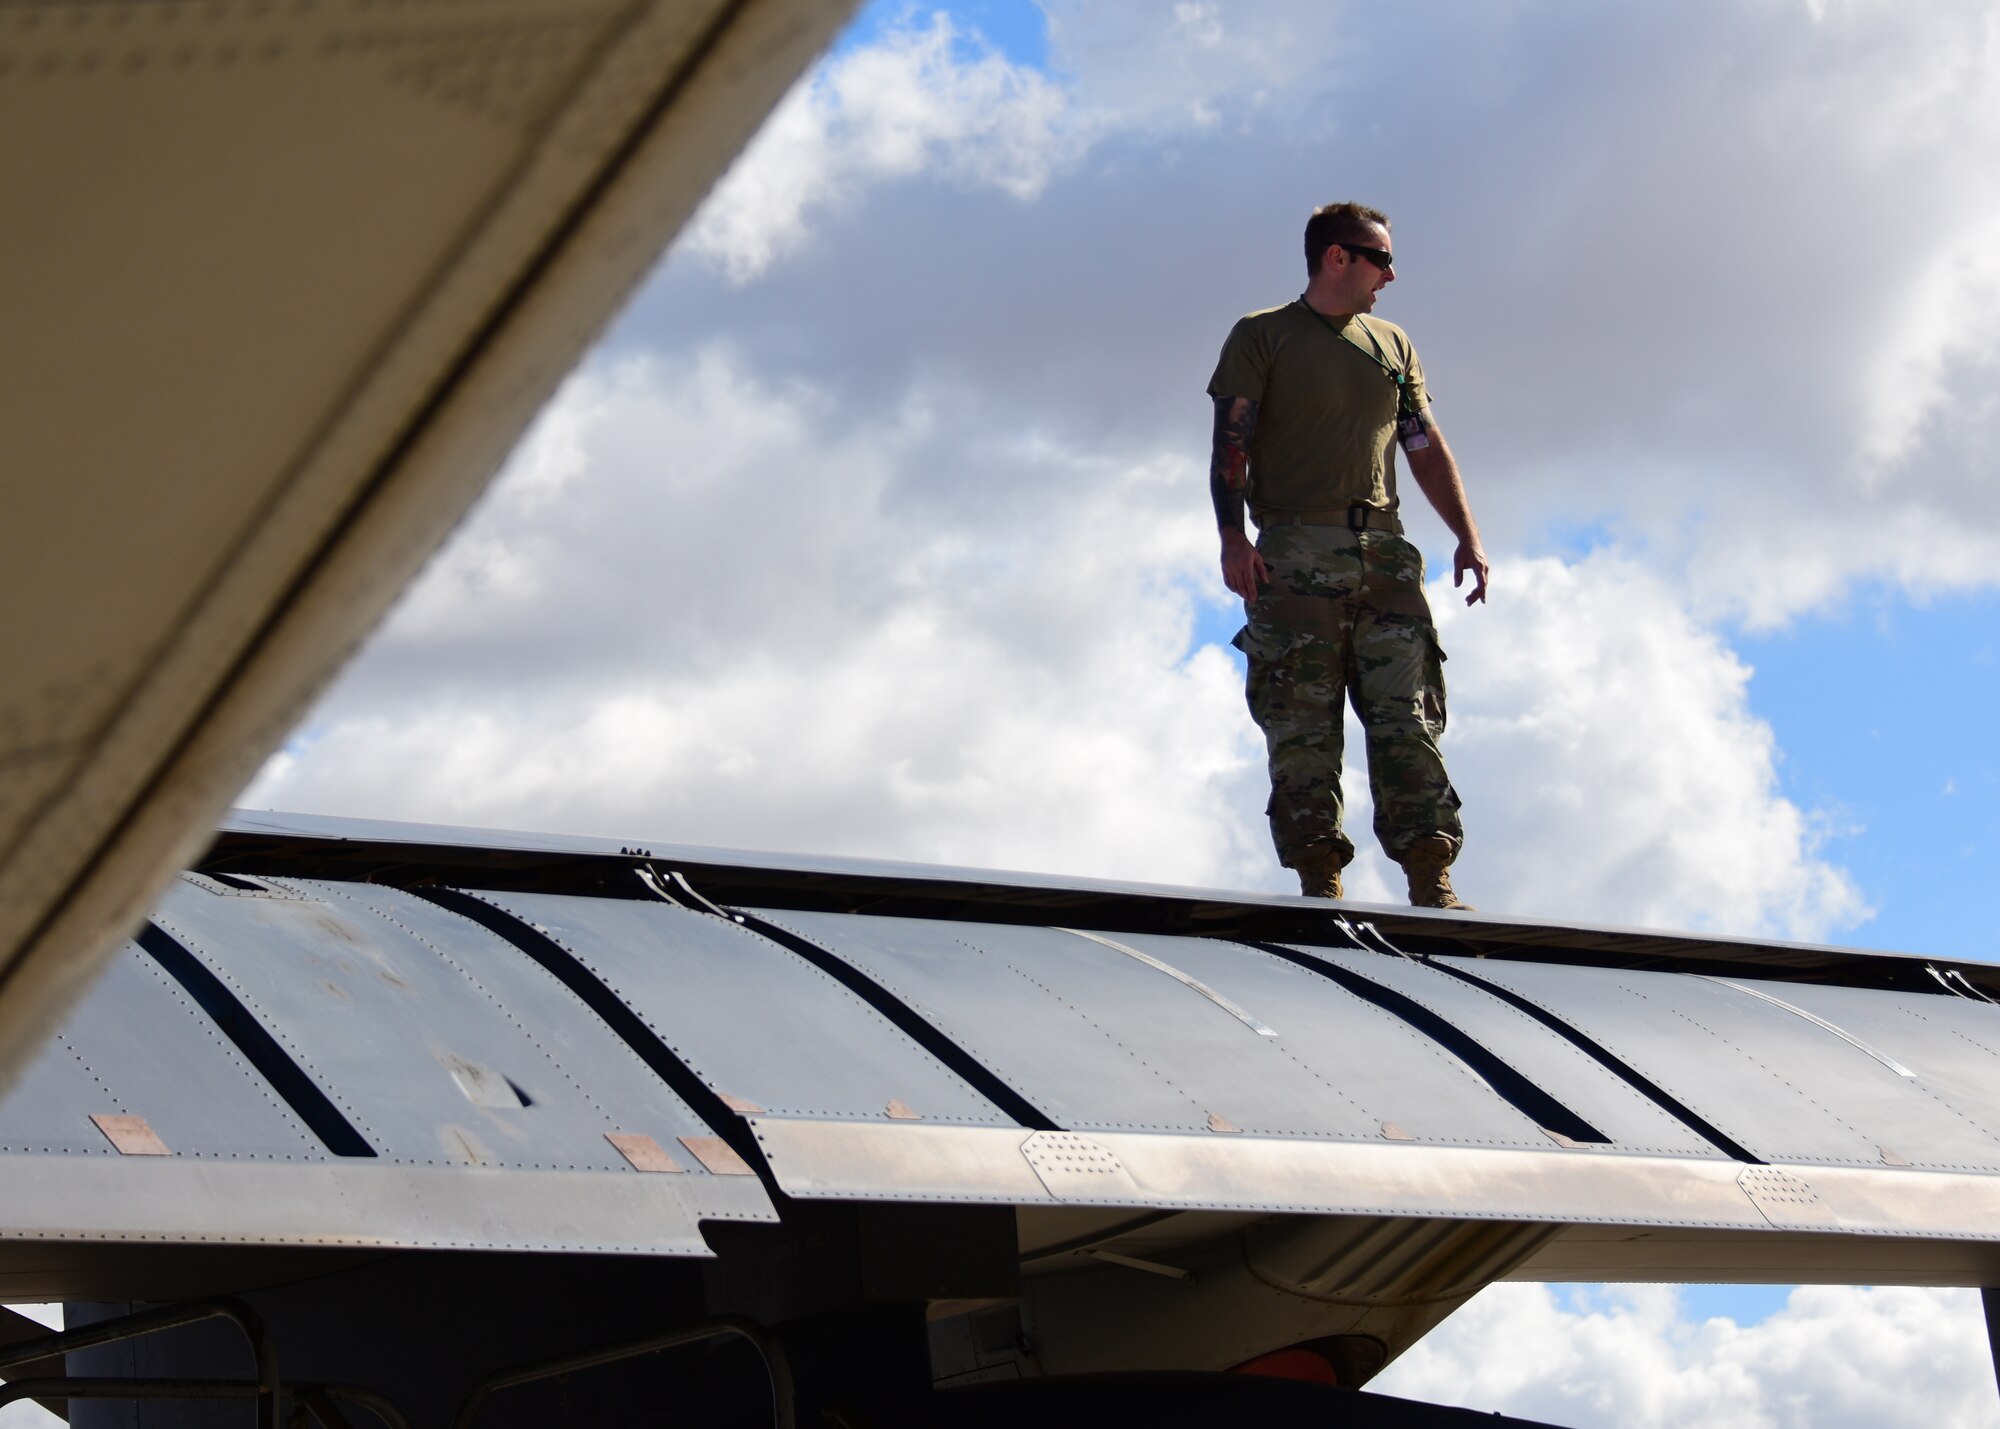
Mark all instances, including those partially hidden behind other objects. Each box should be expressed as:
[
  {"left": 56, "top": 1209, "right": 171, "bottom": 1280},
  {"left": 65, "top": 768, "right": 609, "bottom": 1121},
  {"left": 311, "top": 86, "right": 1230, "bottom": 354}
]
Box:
[{"left": 756, "top": 911, "right": 1554, "bottom": 1149}]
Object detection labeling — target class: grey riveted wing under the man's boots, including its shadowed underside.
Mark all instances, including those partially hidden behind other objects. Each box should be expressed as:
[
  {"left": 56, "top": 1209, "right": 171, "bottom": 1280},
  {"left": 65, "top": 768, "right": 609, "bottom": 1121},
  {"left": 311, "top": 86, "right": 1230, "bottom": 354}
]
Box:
[{"left": 0, "top": 813, "right": 2000, "bottom": 1385}]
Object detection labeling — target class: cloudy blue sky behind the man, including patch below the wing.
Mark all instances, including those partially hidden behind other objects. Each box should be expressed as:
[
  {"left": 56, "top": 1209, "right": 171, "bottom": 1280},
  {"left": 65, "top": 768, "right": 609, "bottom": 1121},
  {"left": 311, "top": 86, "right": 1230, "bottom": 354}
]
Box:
[{"left": 244, "top": 0, "right": 2000, "bottom": 1425}]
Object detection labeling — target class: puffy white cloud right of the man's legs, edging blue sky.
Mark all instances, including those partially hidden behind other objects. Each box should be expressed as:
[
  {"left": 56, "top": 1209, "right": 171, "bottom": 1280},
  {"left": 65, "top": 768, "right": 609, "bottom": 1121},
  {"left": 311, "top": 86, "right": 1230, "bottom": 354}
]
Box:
[{"left": 1432, "top": 550, "right": 1868, "bottom": 939}]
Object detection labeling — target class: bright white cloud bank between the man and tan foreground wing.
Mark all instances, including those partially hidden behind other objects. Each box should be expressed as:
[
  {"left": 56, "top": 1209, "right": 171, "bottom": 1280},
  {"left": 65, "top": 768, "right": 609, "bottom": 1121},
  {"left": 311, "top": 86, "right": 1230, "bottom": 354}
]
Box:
[{"left": 246, "top": 352, "right": 1270, "bottom": 883}]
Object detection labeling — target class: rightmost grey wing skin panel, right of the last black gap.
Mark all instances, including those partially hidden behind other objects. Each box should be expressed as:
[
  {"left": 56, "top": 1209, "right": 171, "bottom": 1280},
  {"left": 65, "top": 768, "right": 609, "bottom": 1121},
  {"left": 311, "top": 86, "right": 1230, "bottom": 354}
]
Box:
[{"left": 1438, "top": 959, "right": 2000, "bottom": 1175}]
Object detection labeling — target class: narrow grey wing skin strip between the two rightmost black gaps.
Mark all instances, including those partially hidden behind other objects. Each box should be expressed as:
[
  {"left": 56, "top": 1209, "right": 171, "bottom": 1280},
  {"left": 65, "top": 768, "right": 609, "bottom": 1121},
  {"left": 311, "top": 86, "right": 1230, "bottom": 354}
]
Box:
[{"left": 1300, "top": 947, "right": 1722, "bottom": 1157}]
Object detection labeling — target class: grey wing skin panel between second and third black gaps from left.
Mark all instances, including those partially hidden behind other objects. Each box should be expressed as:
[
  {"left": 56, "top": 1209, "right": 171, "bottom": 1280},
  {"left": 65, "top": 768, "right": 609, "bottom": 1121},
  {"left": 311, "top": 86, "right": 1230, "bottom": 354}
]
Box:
[{"left": 472, "top": 893, "right": 1014, "bottom": 1125}]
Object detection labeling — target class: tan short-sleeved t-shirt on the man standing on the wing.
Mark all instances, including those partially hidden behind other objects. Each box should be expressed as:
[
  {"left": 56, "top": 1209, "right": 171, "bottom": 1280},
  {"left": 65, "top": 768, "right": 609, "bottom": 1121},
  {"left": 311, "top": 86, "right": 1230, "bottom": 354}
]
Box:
[{"left": 1208, "top": 300, "right": 1430, "bottom": 526}]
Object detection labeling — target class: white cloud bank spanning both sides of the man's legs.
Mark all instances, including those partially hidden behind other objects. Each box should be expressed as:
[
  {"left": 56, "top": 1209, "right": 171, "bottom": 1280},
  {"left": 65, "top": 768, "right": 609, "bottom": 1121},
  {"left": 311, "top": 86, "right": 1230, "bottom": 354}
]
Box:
[{"left": 246, "top": 346, "right": 1866, "bottom": 937}]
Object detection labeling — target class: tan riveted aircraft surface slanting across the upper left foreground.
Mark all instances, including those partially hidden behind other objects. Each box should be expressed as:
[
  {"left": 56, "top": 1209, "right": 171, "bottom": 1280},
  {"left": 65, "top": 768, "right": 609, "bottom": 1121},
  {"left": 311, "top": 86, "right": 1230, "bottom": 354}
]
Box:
[{"left": 0, "top": 0, "right": 852, "bottom": 1081}]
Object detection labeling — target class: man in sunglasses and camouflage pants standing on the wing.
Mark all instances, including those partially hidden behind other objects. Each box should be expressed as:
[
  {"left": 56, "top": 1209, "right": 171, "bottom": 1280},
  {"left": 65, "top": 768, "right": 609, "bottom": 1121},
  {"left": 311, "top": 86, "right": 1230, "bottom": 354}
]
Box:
[{"left": 1208, "top": 204, "right": 1486, "bottom": 909}]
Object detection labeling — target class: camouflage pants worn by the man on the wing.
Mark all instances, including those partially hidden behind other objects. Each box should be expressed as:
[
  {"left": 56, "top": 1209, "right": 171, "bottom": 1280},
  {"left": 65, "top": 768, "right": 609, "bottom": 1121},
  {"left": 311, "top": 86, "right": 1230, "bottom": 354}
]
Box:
[{"left": 1234, "top": 526, "right": 1464, "bottom": 867}]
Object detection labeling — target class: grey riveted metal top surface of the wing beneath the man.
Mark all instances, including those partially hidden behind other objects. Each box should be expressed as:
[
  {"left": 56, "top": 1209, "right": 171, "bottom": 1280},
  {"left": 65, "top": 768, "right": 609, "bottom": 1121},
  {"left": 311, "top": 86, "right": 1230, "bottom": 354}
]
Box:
[{"left": 0, "top": 817, "right": 2000, "bottom": 1281}]
